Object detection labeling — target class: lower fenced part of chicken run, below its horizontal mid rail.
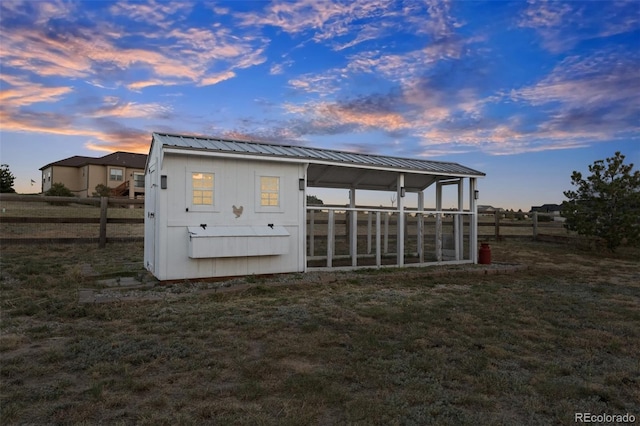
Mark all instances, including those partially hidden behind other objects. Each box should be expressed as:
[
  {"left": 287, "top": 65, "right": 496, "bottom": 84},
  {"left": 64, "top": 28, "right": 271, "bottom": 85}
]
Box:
[{"left": 307, "top": 206, "right": 475, "bottom": 270}]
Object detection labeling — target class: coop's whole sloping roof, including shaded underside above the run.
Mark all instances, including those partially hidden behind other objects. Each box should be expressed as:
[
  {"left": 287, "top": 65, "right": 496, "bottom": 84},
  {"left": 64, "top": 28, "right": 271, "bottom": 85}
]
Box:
[{"left": 152, "top": 133, "right": 485, "bottom": 191}]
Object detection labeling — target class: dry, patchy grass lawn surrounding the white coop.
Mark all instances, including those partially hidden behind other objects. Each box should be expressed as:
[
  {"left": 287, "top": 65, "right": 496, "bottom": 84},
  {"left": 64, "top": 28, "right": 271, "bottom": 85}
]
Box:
[{"left": 0, "top": 241, "right": 640, "bottom": 425}]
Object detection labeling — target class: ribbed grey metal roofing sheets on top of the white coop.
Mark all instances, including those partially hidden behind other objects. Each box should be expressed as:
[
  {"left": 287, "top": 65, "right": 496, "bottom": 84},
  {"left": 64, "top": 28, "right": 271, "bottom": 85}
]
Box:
[{"left": 153, "top": 133, "right": 485, "bottom": 177}]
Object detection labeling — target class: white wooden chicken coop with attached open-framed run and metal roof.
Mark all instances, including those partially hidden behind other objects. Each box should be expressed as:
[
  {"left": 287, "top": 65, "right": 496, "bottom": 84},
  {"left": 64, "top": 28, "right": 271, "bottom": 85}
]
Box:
[{"left": 144, "top": 133, "right": 484, "bottom": 280}]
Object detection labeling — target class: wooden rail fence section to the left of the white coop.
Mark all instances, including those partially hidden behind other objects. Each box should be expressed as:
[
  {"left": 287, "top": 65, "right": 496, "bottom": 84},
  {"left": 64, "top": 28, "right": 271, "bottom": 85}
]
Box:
[{"left": 0, "top": 194, "right": 144, "bottom": 248}]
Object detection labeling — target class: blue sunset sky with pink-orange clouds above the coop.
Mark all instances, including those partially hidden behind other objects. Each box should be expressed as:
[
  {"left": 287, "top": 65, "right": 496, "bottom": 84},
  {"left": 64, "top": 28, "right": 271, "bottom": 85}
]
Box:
[{"left": 0, "top": 0, "right": 640, "bottom": 211}]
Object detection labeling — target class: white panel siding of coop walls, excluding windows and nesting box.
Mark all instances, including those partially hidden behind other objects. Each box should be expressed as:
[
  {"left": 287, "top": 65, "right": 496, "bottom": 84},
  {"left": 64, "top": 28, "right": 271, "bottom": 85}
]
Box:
[{"left": 145, "top": 148, "right": 305, "bottom": 280}]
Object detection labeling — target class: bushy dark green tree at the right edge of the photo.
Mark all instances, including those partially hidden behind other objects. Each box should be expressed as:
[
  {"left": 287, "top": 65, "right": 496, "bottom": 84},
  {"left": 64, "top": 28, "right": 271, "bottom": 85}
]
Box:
[{"left": 562, "top": 152, "right": 640, "bottom": 251}]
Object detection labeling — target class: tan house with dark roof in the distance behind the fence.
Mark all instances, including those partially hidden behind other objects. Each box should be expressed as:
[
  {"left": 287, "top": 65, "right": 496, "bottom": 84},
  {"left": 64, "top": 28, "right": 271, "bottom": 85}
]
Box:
[{"left": 40, "top": 151, "right": 147, "bottom": 198}]
